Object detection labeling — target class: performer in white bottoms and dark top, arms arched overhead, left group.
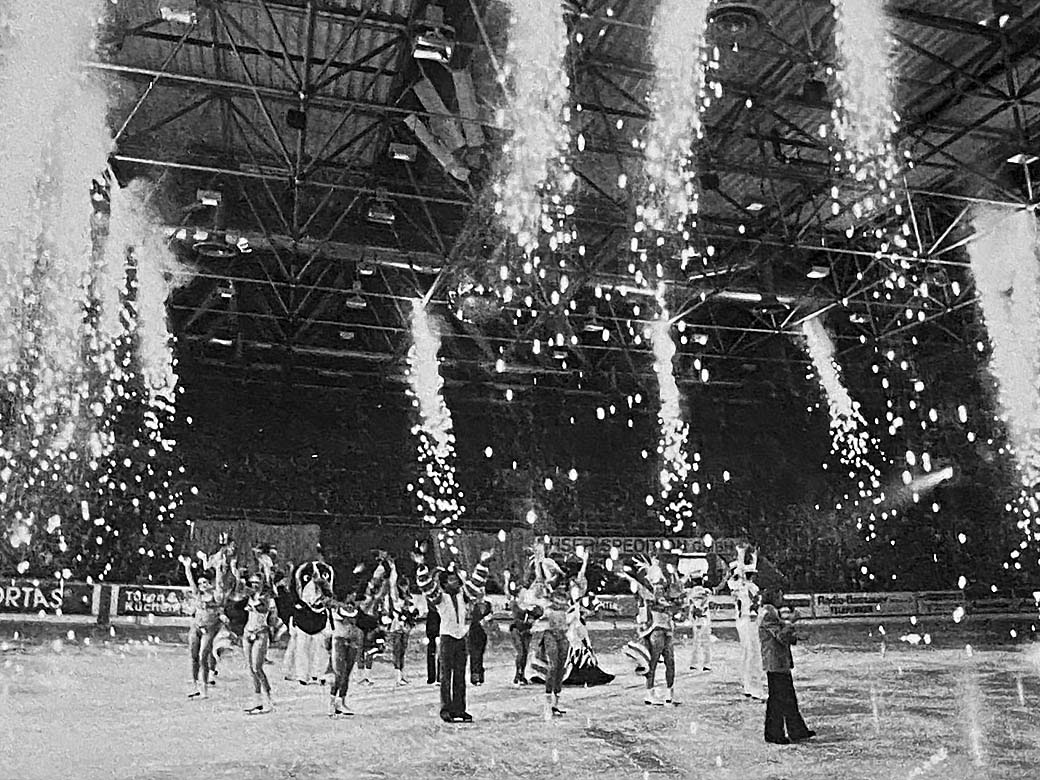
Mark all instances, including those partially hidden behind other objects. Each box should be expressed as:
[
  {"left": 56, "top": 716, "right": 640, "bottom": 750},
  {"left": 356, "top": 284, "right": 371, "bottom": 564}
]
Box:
[{"left": 285, "top": 561, "right": 336, "bottom": 685}]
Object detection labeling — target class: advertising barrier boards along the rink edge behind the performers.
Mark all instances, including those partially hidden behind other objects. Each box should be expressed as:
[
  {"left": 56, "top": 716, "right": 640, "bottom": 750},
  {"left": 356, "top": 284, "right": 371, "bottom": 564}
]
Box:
[{"left": 0, "top": 579, "right": 1037, "bottom": 626}]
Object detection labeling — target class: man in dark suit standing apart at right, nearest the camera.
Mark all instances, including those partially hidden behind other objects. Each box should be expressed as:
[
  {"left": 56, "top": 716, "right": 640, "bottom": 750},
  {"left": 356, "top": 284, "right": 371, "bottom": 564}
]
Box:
[{"left": 758, "top": 588, "right": 816, "bottom": 745}]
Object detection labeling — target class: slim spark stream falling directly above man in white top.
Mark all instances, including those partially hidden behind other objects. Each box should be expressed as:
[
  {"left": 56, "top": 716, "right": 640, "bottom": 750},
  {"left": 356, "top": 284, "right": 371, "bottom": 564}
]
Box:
[{"left": 408, "top": 300, "right": 465, "bottom": 528}]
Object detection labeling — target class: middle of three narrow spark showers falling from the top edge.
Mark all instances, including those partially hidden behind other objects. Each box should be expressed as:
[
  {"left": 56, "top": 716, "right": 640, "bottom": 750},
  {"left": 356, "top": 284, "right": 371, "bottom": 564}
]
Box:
[{"left": 643, "top": 0, "right": 708, "bottom": 231}]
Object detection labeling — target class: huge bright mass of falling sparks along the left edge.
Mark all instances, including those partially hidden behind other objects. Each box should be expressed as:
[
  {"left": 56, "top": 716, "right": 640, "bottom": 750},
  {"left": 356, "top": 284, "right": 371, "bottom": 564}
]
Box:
[{"left": 0, "top": 0, "right": 189, "bottom": 571}]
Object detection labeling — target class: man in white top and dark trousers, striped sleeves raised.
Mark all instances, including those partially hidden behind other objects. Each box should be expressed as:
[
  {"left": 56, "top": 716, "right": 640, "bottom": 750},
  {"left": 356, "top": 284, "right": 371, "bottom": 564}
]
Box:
[{"left": 412, "top": 544, "right": 494, "bottom": 723}]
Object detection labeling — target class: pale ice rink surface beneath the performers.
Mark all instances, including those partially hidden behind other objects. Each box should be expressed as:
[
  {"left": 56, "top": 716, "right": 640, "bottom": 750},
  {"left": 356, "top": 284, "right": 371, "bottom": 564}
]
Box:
[{"left": 0, "top": 625, "right": 1040, "bottom": 780}]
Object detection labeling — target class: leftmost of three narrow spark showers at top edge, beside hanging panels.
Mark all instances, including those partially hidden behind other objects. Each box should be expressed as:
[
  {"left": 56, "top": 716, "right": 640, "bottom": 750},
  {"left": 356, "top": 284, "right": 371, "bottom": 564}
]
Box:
[{"left": 495, "top": 0, "right": 574, "bottom": 254}]
